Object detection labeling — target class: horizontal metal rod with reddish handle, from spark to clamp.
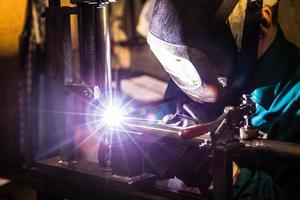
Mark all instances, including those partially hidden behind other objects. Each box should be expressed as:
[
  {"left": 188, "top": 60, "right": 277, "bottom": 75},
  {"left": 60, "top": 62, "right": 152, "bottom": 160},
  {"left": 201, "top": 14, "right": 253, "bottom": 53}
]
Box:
[{"left": 122, "top": 97, "right": 255, "bottom": 147}]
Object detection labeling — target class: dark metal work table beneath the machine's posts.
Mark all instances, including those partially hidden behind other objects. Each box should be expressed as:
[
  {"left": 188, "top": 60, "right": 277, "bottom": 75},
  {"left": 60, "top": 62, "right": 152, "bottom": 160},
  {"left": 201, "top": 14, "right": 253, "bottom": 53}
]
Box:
[{"left": 30, "top": 157, "right": 206, "bottom": 200}]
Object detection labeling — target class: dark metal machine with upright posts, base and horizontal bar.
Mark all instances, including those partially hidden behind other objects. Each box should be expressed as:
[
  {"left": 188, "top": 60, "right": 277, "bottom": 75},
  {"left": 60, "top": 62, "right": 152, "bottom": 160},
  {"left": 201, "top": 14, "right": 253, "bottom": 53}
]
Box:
[{"left": 30, "top": 0, "right": 300, "bottom": 200}]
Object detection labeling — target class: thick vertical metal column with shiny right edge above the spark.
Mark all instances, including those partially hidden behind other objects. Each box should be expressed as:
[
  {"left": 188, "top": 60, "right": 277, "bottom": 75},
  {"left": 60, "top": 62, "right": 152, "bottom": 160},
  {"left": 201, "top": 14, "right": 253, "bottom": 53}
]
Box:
[{"left": 76, "top": 1, "right": 112, "bottom": 94}]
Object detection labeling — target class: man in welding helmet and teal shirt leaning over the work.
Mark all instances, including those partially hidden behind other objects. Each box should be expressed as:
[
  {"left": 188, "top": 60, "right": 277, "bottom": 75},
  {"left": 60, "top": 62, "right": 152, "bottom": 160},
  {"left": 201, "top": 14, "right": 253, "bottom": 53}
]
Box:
[{"left": 147, "top": 0, "right": 300, "bottom": 199}]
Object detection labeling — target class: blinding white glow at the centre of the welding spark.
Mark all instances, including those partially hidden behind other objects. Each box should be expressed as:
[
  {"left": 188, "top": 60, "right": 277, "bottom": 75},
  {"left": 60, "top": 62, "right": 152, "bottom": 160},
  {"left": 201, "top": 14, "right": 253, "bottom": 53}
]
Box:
[{"left": 102, "top": 105, "right": 124, "bottom": 126}]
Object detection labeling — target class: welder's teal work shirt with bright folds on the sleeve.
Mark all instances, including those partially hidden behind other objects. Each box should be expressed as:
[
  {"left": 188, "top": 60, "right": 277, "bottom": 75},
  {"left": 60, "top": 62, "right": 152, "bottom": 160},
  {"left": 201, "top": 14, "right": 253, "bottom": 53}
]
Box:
[{"left": 234, "top": 28, "right": 300, "bottom": 200}]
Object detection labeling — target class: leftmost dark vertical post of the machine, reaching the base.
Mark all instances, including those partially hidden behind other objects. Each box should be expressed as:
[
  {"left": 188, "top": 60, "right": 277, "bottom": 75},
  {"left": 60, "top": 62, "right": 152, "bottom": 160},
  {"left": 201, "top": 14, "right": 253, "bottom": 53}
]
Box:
[{"left": 46, "top": 0, "right": 75, "bottom": 162}]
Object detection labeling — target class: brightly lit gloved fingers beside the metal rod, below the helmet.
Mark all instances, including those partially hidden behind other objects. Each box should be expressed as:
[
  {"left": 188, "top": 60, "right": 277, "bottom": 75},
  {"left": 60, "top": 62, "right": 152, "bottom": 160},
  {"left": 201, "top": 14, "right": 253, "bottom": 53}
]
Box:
[{"left": 161, "top": 114, "right": 197, "bottom": 127}]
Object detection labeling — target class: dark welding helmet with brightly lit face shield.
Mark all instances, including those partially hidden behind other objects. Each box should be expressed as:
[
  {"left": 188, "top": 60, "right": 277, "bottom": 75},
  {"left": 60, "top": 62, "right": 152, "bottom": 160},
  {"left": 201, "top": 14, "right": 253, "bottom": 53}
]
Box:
[{"left": 147, "top": 0, "right": 277, "bottom": 103}]
